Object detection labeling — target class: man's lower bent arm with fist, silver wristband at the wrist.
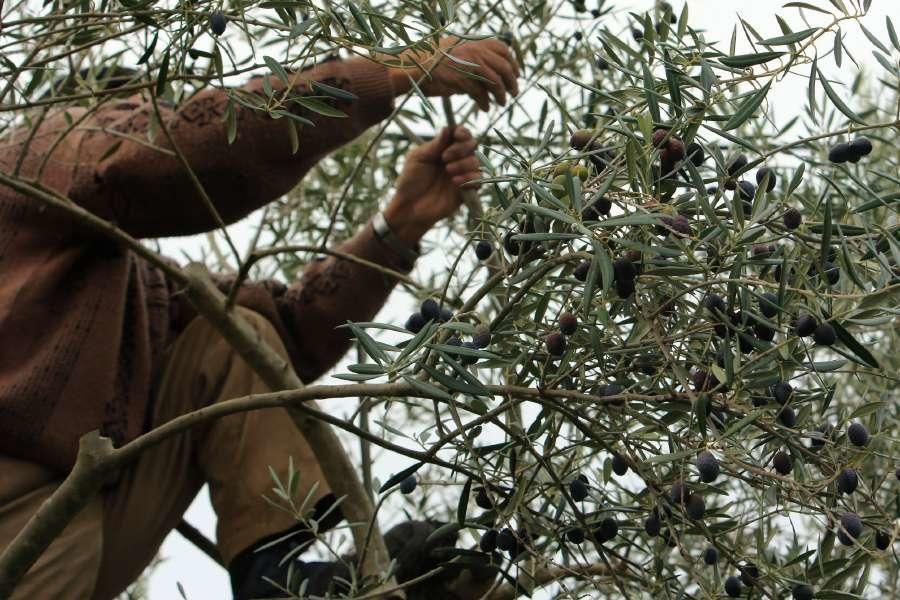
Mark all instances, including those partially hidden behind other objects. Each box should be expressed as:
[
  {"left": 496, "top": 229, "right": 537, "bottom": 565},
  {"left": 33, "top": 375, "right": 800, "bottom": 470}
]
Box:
[{"left": 276, "top": 128, "right": 481, "bottom": 382}]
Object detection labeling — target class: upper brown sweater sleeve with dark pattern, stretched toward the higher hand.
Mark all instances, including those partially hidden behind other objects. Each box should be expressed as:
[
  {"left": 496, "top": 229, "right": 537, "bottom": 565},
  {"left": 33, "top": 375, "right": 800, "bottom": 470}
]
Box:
[{"left": 68, "top": 57, "right": 394, "bottom": 237}]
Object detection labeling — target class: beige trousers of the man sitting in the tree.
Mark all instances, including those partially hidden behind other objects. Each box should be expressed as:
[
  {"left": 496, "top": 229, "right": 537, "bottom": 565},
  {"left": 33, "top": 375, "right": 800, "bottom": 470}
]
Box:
[{"left": 0, "top": 309, "right": 328, "bottom": 600}]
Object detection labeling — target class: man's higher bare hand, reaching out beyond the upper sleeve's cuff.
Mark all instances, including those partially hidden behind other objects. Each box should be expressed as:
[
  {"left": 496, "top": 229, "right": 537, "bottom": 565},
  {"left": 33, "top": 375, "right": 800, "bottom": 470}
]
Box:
[{"left": 394, "top": 36, "right": 519, "bottom": 111}]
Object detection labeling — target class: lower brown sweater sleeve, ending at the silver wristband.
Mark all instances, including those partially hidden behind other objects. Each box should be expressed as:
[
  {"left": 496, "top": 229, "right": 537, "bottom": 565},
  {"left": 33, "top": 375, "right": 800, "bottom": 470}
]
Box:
[{"left": 276, "top": 223, "right": 413, "bottom": 383}]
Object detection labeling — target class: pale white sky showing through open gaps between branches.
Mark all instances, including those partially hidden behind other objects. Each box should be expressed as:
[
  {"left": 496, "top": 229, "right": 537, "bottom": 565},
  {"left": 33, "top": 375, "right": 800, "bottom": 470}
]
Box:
[{"left": 148, "top": 0, "right": 900, "bottom": 600}]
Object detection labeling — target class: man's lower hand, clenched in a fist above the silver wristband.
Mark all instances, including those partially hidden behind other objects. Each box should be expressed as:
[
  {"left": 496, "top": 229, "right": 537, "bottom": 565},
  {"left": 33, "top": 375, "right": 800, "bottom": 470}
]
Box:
[{"left": 384, "top": 127, "right": 481, "bottom": 244}]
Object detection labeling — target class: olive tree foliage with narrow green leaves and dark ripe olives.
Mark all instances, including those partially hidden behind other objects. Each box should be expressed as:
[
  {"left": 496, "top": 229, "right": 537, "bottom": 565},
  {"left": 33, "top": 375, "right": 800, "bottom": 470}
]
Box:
[{"left": 0, "top": 0, "right": 900, "bottom": 600}]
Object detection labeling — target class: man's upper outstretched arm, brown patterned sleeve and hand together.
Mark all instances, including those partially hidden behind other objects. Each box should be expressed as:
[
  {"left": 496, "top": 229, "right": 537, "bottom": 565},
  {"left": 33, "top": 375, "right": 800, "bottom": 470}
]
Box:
[{"left": 0, "top": 37, "right": 518, "bottom": 237}]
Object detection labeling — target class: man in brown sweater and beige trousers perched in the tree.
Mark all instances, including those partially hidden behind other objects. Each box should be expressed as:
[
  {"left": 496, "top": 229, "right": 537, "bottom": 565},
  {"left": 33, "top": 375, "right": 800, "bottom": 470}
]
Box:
[{"left": 0, "top": 38, "right": 518, "bottom": 600}]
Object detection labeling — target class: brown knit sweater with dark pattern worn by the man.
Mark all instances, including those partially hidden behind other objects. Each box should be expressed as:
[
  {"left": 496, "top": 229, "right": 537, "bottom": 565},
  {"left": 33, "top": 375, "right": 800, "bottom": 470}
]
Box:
[{"left": 0, "top": 59, "right": 412, "bottom": 470}]
